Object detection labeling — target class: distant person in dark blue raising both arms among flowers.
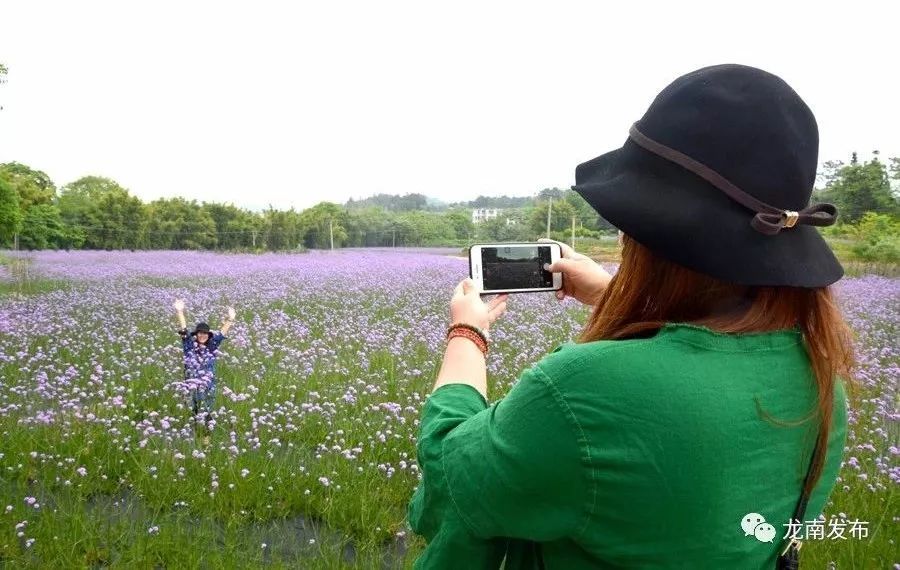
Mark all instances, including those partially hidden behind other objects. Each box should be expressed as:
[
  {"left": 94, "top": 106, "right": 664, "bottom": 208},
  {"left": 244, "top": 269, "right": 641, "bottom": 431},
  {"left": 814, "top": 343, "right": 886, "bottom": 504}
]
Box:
[{"left": 174, "top": 299, "right": 235, "bottom": 421}]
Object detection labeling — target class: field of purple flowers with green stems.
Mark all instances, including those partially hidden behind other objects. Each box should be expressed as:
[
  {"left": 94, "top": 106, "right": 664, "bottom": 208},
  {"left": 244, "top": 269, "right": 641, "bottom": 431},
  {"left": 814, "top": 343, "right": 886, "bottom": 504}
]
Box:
[{"left": 0, "top": 250, "right": 900, "bottom": 568}]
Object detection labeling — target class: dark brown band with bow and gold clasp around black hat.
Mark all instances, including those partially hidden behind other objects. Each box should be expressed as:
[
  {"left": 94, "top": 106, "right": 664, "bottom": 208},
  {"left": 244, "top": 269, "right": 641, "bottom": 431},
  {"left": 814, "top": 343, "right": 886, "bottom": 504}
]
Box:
[{"left": 628, "top": 123, "right": 837, "bottom": 235}]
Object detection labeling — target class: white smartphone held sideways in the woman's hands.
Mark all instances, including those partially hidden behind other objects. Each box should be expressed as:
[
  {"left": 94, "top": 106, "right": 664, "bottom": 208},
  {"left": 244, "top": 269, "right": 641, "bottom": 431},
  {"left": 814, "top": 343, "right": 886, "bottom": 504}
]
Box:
[{"left": 469, "top": 243, "right": 562, "bottom": 295}]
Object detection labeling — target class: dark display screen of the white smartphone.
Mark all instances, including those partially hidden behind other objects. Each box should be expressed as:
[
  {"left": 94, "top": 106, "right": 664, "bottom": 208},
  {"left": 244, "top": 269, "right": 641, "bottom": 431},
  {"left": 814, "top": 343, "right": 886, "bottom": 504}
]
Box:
[{"left": 481, "top": 245, "right": 553, "bottom": 290}]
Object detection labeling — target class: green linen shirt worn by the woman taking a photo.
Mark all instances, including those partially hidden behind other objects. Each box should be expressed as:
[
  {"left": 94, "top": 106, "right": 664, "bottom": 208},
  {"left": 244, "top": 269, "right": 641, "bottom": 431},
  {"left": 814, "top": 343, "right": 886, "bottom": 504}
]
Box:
[{"left": 408, "top": 323, "right": 847, "bottom": 569}]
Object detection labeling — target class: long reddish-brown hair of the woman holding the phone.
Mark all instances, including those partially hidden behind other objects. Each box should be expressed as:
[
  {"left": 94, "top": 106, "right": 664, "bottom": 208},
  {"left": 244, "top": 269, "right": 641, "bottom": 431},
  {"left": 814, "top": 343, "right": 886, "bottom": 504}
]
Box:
[{"left": 580, "top": 235, "right": 854, "bottom": 493}]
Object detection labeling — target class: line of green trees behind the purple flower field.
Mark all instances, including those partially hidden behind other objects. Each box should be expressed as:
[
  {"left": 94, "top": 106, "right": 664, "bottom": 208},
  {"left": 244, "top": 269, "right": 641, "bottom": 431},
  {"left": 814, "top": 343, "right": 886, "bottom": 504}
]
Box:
[{"left": 0, "top": 153, "right": 900, "bottom": 251}]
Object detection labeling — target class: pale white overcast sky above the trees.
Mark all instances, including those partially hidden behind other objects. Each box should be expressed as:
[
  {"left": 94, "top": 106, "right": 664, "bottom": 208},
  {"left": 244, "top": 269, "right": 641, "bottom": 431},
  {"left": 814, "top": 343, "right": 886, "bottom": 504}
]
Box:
[{"left": 0, "top": 0, "right": 900, "bottom": 209}]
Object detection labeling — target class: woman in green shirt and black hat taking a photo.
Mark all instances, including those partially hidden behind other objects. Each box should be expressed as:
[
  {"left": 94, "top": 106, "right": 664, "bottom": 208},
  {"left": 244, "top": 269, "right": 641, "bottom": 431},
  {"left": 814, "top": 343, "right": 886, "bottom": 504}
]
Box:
[{"left": 409, "top": 65, "right": 853, "bottom": 569}]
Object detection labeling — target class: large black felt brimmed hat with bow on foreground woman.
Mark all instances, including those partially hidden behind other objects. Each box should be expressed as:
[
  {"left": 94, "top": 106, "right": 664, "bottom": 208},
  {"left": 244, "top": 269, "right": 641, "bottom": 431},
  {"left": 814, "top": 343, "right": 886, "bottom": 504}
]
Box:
[{"left": 573, "top": 65, "right": 843, "bottom": 288}]
